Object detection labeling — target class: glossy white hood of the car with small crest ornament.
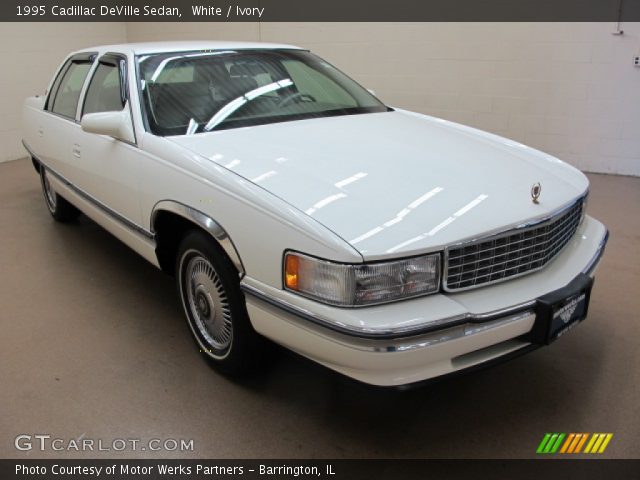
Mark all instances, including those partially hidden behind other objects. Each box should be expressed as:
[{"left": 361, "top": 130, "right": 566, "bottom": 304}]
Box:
[{"left": 170, "top": 110, "right": 588, "bottom": 260}]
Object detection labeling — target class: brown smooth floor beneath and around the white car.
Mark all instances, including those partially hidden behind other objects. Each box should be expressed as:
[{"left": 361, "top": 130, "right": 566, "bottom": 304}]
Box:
[{"left": 0, "top": 160, "right": 640, "bottom": 458}]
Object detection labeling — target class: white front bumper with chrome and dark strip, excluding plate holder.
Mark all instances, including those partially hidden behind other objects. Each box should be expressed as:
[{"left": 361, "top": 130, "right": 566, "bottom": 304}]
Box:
[{"left": 242, "top": 216, "right": 608, "bottom": 386}]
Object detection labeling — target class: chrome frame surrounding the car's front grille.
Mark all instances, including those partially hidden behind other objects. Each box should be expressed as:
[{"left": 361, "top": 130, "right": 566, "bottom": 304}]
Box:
[{"left": 441, "top": 190, "right": 589, "bottom": 293}]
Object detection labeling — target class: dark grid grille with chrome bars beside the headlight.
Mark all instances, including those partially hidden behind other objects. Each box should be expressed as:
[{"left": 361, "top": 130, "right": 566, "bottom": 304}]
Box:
[{"left": 445, "top": 199, "right": 583, "bottom": 291}]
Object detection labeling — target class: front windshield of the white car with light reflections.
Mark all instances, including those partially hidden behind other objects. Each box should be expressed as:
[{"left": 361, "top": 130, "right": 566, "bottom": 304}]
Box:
[{"left": 137, "top": 50, "right": 389, "bottom": 136}]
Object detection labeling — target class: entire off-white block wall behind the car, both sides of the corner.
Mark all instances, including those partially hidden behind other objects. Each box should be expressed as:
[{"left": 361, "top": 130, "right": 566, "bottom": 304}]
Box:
[{"left": 0, "top": 22, "right": 640, "bottom": 175}]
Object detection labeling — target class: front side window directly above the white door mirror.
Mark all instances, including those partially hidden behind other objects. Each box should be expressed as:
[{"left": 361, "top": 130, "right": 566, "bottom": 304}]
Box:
[{"left": 82, "top": 63, "right": 125, "bottom": 115}]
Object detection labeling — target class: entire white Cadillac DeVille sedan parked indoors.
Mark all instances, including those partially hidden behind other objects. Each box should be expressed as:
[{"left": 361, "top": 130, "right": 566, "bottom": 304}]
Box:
[{"left": 23, "top": 42, "right": 608, "bottom": 386}]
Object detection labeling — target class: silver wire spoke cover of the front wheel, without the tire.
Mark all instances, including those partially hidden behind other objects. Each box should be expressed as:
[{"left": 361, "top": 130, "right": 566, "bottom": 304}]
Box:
[{"left": 182, "top": 250, "right": 233, "bottom": 352}]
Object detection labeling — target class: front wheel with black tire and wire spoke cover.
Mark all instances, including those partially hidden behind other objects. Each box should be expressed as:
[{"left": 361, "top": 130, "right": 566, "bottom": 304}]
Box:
[{"left": 175, "top": 230, "right": 265, "bottom": 376}]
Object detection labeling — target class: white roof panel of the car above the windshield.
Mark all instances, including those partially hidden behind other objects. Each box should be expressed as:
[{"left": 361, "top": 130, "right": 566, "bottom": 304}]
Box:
[{"left": 75, "top": 40, "right": 301, "bottom": 55}]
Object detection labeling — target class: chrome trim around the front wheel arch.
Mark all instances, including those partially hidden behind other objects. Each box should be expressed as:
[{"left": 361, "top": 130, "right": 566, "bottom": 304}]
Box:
[{"left": 150, "top": 200, "right": 245, "bottom": 278}]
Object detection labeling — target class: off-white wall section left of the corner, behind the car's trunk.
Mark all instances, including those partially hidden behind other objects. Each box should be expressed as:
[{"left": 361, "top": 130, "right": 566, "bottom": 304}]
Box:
[{"left": 0, "top": 23, "right": 126, "bottom": 161}]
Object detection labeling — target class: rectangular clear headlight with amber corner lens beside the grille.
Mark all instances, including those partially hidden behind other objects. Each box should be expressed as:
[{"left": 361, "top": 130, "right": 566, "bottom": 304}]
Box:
[{"left": 284, "top": 252, "right": 440, "bottom": 307}]
